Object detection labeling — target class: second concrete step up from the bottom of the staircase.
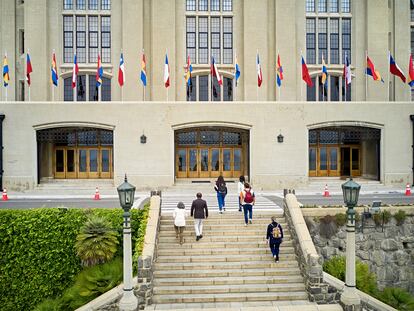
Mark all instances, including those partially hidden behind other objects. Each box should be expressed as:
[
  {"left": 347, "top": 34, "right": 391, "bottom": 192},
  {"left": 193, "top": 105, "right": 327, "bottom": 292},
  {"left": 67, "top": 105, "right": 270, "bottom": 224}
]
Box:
[{"left": 154, "top": 283, "right": 305, "bottom": 296}]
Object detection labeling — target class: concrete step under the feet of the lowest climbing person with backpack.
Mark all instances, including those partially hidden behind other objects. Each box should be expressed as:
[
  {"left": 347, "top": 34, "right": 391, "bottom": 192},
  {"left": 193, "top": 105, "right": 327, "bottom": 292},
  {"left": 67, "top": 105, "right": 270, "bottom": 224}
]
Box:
[{"left": 154, "top": 256, "right": 298, "bottom": 270}]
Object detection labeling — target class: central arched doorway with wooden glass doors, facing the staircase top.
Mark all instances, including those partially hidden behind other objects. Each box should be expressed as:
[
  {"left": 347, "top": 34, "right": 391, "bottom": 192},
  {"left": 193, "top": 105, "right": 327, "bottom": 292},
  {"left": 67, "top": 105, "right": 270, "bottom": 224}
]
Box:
[{"left": 174, "top": 127, "right": 249, "bottom": 179}]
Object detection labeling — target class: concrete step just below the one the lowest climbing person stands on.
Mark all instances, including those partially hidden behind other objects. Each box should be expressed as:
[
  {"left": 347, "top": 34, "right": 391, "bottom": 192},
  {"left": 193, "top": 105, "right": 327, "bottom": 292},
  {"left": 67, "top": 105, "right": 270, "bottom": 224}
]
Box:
[{"left": 154, "top": 266, "right": 300, "bottom": 280}]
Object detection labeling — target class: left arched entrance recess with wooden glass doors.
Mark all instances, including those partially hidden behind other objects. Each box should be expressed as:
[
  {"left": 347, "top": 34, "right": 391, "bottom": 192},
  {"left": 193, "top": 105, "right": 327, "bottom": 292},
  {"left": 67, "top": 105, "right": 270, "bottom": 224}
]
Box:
[{"left": 36, "top": 127, "right": 113, "bottom": 182}]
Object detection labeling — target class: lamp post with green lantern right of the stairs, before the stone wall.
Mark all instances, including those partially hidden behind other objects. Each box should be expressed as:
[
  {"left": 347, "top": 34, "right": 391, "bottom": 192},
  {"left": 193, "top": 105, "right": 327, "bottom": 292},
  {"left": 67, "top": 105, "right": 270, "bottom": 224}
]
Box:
[{"left": 341, "top": 177, "right": 361, "bottom": 311}]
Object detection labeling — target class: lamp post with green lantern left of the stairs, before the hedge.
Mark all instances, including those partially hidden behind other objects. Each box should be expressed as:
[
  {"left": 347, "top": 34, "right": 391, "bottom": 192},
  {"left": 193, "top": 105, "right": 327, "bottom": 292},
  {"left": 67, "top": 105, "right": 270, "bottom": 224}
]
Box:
[{"left": 117, "top": 174, "right": 138, "bottom": 311}]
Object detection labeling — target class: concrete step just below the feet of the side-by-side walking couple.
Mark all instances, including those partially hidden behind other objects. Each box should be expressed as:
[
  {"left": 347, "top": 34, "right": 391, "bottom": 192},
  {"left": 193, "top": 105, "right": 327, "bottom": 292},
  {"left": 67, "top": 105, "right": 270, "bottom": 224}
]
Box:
[{"left": 158, "top": 240, "right": 293, "bottom": 249}]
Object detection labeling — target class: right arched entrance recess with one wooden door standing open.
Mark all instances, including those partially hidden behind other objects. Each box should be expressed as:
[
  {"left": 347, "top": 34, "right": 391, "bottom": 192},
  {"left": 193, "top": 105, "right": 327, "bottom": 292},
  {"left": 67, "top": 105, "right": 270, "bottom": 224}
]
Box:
[{"left": 309, "top": 126, "right": 381, "bottom": 180}]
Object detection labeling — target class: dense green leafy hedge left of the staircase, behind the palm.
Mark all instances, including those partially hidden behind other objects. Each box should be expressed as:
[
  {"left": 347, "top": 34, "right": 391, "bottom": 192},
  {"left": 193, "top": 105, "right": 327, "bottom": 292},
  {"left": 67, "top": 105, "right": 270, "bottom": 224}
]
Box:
[{"left": 0, "top": 208, "right": 147, "bottom": 311}]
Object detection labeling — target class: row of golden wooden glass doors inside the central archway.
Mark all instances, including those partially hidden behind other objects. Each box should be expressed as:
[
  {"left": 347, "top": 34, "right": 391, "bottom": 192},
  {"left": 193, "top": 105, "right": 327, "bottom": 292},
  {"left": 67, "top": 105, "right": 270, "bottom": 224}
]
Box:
[{"left": 176, "top": 146, "right": 244, "bottom": 178}]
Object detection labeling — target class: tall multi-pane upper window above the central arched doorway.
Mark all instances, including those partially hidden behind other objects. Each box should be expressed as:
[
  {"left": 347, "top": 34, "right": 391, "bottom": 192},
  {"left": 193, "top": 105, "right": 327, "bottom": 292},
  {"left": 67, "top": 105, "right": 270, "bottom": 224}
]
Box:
[{"left": 186, "top": 0, "right": 233, "bottom": 64}]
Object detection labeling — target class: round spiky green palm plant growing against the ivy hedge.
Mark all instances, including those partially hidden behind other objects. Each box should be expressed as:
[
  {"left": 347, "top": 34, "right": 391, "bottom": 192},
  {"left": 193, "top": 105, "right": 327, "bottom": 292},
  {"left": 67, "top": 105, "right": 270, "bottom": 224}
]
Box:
[{"left": 75, "top": 216, "right": 119, "bottom": 267}]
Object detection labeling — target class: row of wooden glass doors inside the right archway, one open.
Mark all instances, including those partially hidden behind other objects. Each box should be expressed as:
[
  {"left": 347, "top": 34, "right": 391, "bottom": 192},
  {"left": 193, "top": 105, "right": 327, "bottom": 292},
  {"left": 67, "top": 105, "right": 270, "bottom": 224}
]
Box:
[{"left": 309, "top": 145, "right": 361, "bottom": 177}]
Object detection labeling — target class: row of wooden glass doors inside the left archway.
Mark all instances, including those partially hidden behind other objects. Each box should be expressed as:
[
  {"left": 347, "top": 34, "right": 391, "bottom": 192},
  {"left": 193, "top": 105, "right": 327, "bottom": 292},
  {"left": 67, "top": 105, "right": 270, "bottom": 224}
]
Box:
[{"left": 53, "top": 147, "right": 113, "bottom": 179}]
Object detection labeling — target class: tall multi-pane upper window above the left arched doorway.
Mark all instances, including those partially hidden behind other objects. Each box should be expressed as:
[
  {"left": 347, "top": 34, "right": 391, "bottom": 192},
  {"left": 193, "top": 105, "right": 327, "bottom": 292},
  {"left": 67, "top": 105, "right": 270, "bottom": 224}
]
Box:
[{"left": 63, "top": 0, "right": 111, "bottom": 64}]
